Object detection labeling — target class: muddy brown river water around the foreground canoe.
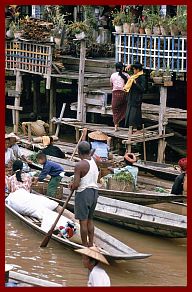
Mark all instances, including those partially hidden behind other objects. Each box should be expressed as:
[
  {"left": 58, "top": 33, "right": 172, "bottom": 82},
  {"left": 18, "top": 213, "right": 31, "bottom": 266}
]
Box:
[{"left": 6, "top": 204, "right": 187, "bottom": 286}]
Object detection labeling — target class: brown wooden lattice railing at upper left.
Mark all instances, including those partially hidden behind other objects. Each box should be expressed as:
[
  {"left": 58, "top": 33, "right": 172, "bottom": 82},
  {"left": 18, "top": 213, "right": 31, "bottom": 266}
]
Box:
[{"left": 5, "top": 41, "right": 52, "bottom": 89}]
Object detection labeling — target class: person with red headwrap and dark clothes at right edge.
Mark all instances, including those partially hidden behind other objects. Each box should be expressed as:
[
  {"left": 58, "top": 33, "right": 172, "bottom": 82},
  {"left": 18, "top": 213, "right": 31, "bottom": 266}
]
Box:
[{"left": 171, "top": 158, "right": 187, "bottom": 195}]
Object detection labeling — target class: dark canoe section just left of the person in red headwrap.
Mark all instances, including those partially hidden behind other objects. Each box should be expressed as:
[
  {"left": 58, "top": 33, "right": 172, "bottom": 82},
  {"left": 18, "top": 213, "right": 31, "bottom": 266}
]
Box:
[{"left": 133, "top": 160, "right": 180, "bottom": 181}]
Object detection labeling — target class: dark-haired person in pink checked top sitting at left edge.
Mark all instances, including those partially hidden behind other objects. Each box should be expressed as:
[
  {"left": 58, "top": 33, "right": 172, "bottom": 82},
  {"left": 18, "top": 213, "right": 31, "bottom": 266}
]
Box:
[{"left": 6, "top": 160, "right": 33, "bottom": 193}]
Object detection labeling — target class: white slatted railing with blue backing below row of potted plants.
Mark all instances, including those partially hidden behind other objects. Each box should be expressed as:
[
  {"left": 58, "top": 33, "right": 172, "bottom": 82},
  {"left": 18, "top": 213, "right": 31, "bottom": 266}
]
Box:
[{"left": 115, "top": 34, "right": 187, "bottom": 72}]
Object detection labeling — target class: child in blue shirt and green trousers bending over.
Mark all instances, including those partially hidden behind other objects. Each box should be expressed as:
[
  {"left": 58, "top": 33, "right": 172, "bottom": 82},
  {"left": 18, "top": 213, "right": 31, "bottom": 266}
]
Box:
[{"left": 35, "top": 152, "right": 64, "bottom": 197}]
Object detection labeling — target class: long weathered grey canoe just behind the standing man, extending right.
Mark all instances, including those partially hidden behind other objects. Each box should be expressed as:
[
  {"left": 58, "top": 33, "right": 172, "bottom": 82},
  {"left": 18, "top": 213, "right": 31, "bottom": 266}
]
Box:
[{"left": 59, "top": 192, "right": 187, "bottom": 238}]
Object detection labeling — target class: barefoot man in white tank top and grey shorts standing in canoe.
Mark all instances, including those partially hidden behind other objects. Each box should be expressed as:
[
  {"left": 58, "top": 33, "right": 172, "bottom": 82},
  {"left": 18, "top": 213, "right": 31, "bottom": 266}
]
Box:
[{"left": 70, "top": 141, "right": 99, "bottom": 247}]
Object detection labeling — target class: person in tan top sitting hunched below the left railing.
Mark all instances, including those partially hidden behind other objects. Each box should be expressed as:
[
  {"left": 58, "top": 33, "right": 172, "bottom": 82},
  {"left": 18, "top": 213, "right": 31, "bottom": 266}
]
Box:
[{"left": 22, "top": 113, "right": 49, "bottom": 137}]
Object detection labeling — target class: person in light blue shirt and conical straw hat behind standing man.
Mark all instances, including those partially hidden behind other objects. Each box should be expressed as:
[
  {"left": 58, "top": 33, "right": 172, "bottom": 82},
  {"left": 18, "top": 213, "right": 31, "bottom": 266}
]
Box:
[{"left": 82, "top": 128, "right": 111, "bottom": 161}]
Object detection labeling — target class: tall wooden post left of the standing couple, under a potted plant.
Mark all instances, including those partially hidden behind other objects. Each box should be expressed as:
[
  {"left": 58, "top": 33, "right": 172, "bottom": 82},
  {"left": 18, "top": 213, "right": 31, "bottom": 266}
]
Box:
[{"left": 77, "top": 39, "right": 86, "bottom": 122}]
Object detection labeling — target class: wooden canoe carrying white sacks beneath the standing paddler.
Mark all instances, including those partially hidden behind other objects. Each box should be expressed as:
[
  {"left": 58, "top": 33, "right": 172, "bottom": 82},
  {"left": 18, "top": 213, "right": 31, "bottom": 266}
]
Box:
[{"left": 5, "top": 200, "right": 151, "bottom": 260}]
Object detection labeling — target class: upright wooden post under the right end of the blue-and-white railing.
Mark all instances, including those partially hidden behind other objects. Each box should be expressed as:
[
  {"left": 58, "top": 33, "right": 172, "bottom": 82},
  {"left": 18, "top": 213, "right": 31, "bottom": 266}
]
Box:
[{"left": 157, "top": 86, "right": 167, "bottom": 163}]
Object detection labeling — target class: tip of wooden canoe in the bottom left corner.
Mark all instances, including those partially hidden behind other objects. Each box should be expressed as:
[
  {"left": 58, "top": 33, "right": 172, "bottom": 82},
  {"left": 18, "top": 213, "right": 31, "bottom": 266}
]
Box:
[{"left": 8, "top": 271, "right": 66, "bottom": 287}]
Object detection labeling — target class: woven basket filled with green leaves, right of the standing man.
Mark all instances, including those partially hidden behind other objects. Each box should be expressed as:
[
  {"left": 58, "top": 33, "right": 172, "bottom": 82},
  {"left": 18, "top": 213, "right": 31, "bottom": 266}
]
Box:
[{"left": 107, "top": 177, "right": 135, "bottom": 192}]
